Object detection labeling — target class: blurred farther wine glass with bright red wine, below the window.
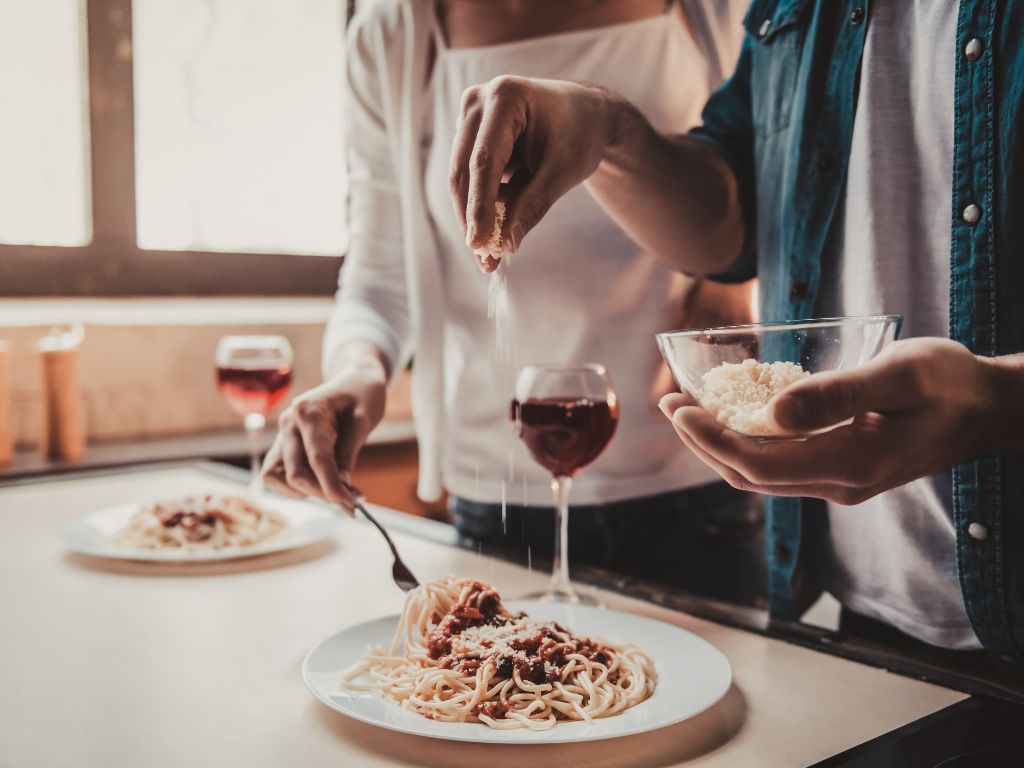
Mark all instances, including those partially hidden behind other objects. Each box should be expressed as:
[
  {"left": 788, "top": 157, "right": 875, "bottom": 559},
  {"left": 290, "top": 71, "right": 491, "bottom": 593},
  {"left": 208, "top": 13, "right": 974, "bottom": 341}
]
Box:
[{"left": 216, "top": 336, "right": 292, "bottom": 495}]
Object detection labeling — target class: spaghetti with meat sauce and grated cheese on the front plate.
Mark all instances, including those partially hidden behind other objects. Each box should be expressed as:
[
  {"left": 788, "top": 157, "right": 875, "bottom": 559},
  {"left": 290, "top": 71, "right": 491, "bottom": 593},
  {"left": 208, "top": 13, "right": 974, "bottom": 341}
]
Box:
[{"left": 343, "top": 579, "right": 655, "bottom": 730}]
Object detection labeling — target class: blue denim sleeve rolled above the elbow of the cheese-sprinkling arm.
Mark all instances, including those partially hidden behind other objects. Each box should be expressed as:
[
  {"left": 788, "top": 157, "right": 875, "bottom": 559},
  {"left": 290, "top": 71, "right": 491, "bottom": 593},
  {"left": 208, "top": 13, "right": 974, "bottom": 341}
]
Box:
[{"left": 689, "top": 37, "right": 757, "bottom": 283}]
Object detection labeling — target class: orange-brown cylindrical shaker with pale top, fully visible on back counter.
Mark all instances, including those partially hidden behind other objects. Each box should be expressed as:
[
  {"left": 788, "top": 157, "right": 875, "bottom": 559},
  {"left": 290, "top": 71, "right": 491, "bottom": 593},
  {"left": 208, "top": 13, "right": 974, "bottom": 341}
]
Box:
[{"left": 37, "top": 326, "right": 85, "bottom": 461}]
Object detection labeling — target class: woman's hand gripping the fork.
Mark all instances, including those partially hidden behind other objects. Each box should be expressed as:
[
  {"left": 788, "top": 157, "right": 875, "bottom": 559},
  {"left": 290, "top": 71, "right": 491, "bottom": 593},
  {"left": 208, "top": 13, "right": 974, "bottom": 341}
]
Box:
[{"left": 263, "top": 356, "right": 387, "bottom": 513}]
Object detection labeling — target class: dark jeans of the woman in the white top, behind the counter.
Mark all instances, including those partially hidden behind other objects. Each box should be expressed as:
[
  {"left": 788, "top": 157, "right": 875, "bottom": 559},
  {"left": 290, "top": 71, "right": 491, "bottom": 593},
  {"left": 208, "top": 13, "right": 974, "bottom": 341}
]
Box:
[{"left": 450, "top": 482, "right": 766, "bottom": 605}]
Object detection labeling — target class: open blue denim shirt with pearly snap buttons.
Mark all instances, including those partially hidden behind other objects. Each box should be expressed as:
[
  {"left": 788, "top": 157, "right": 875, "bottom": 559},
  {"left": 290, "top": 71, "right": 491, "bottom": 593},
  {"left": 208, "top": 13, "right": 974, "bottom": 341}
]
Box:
[{"left": 692, "top": 0, "right": 1024, "bottom": 660}]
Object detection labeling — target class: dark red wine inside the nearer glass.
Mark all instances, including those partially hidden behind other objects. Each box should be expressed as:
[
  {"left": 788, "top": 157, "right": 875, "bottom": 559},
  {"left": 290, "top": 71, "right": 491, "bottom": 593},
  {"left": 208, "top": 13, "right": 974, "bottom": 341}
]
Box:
[{"left": 511, "top": 397, "right": 618, "bottom": 477}]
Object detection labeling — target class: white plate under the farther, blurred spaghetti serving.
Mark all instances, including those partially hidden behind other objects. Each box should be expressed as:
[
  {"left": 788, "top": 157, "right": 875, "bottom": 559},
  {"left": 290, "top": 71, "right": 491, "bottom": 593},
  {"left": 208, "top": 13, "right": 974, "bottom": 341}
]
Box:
[{"left": 60, "top": 497, "right": 338, "bottom": 562}]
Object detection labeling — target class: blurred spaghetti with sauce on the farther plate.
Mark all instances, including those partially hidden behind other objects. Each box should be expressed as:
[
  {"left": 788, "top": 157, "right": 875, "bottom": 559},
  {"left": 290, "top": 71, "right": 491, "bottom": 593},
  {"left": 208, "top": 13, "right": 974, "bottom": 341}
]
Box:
[{"left": 115, "top": 495, "right": 286, "bottom": 551}]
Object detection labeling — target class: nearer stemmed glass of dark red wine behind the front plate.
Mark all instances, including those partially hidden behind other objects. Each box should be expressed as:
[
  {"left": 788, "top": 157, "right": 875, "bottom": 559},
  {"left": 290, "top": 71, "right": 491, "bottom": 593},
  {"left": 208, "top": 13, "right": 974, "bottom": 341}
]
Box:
[{"left": 510, "top": 365, "right": 618, "bottom": 605}]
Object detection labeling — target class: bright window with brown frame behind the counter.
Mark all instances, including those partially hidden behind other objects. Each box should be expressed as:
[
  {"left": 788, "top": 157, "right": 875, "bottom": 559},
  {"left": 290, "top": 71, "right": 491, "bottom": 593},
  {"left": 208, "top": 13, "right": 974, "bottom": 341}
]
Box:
[{"left": 0, "top": 0, "right": 350, "bottom": 296}]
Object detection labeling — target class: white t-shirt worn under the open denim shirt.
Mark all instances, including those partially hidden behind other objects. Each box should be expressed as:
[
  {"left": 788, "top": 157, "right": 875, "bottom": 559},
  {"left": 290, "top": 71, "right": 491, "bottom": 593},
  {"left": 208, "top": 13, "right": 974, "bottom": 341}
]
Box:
[{"left": 814, "top": 0, "right": 980, "bottom": 649}]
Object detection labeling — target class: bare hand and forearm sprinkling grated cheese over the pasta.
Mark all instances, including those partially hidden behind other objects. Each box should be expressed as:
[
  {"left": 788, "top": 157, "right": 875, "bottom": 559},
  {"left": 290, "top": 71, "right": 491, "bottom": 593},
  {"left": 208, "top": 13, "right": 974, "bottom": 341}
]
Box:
[{"left": 449, "top": 76, "right": 744, "bottom": 275}]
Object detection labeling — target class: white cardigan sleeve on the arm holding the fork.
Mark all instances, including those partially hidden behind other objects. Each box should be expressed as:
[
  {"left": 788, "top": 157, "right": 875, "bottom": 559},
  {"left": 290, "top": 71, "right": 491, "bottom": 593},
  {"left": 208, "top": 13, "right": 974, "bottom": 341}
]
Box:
[{"left": 323, "top": 13, "right": 411, "bottom": 377}]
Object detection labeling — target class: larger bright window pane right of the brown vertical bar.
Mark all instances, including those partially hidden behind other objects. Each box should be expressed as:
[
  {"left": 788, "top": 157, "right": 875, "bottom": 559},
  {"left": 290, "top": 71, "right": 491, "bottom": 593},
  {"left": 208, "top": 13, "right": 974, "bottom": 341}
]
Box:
[{"left": 132, "top": 0, "right": 345, "bottom": 259}]
